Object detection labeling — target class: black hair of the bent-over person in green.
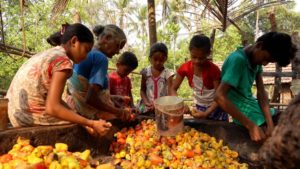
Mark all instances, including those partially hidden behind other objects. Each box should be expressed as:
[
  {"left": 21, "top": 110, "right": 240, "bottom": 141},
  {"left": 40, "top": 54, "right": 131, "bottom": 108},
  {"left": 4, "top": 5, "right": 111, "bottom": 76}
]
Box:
[{"left": 256, "top": 32, "right": 297, "bottom": 66}]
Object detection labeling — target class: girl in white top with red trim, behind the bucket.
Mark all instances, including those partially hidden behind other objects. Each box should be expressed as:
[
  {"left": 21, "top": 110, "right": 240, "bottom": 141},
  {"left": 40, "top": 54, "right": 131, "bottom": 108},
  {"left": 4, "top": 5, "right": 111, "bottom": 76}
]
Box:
[{"left": 140, "top": 43, "right": 174, "bottom": 113}]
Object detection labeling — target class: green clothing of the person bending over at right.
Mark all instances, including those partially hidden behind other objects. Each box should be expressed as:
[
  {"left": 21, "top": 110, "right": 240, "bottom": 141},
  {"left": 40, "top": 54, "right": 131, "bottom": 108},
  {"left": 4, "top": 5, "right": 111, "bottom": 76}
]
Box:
[{"left": 222, "top": 47, "right": 275, "bottom": 125}]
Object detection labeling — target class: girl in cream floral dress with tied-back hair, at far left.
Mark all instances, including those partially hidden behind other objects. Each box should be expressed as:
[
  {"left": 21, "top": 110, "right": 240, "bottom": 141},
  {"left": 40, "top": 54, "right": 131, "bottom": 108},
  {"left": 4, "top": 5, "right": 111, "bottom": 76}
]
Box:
[{"left": 7, "top": 24, "right": 111, "bottom": 135}]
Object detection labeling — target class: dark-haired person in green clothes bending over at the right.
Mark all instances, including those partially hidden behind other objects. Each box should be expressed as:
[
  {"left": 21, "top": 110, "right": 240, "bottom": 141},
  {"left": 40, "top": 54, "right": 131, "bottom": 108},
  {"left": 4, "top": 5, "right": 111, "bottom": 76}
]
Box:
[{"left": 215, "top": 32, "right": 297, "bottom": 141}]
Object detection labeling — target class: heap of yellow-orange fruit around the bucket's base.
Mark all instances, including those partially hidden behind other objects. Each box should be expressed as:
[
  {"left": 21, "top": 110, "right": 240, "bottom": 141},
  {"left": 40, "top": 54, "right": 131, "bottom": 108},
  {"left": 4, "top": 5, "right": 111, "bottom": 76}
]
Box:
[{"left": 110, "top": 120, "right": 248, "bottom": 169}]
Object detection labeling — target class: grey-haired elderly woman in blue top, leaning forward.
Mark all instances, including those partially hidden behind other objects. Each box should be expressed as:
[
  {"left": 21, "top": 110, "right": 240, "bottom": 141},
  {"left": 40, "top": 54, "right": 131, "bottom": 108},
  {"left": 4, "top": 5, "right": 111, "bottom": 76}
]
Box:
[{"left": 65, "top": 25, "right": 131, "bottom": 121}]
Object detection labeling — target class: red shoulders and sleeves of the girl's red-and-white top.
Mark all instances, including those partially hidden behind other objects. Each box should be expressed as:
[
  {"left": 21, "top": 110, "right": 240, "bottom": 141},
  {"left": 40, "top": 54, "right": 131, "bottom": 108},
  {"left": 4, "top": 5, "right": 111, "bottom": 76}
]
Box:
[{"left": 177, "top": 60, "right": 221, "bottom": 89}]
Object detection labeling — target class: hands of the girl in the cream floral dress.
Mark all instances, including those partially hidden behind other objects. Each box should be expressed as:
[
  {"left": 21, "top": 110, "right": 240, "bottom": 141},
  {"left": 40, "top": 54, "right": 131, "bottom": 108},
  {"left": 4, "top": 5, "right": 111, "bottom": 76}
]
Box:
[{"left": 85, "top": 119, "right": 112, "bottom": 136}]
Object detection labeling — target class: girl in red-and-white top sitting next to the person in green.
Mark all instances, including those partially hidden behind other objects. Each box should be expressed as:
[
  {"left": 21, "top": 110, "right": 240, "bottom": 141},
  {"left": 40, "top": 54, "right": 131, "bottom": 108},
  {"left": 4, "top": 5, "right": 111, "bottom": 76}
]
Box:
[{"left": 171, "top": 34, "right": 228, "bottom": 121}]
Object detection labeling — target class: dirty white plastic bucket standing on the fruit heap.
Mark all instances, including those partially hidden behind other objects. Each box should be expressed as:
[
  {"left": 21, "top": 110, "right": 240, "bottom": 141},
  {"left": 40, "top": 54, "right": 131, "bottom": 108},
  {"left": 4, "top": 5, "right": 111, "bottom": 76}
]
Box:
[{"left": 154, "top": 96, "right": 184, "bottom": 136}]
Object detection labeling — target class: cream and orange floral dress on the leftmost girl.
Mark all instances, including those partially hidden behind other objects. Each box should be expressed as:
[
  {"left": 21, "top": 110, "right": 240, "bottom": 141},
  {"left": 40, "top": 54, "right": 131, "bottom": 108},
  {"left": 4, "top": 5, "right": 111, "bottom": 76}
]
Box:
[{"left": 6, "top": 46, "right": 73, "bottom": 127}]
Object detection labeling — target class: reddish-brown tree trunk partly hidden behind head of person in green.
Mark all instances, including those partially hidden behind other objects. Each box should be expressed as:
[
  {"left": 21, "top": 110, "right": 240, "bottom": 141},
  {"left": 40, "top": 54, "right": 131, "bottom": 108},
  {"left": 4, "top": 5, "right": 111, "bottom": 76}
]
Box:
[{"left": 269, "top": 8, "right": 282, "bottom": 103}]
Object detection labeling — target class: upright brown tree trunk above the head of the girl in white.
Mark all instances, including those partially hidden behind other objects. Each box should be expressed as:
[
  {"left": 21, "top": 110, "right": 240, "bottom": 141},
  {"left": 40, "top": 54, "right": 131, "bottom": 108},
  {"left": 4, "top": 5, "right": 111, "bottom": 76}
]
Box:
[{"left": 148, "top": 0, "right": 157, "bottom": 46}]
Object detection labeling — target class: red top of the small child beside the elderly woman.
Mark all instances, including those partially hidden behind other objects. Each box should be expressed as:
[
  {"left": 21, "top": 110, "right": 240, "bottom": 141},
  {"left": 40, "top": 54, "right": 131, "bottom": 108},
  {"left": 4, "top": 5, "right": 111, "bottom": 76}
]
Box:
[{"left": 109, "top": 72, "right": 131, "bottom": 96}]
